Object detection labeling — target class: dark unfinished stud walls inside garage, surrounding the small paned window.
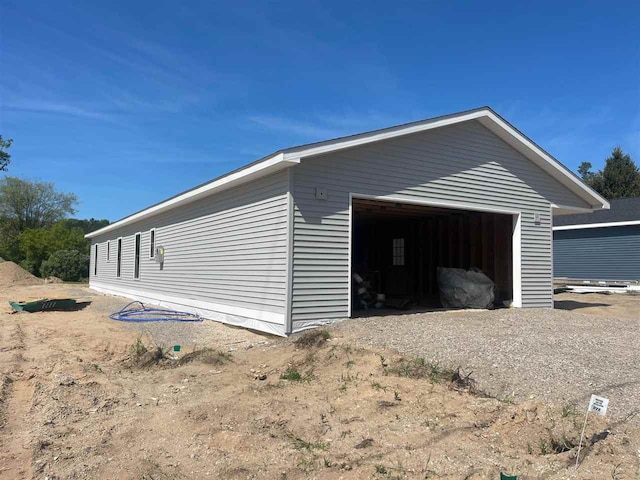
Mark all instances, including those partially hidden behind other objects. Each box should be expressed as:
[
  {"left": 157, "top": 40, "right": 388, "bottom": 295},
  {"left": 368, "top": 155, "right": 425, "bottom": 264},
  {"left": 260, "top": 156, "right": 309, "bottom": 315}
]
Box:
[{"left": 353, "top": 209, "right": 513, "bottom": 305}]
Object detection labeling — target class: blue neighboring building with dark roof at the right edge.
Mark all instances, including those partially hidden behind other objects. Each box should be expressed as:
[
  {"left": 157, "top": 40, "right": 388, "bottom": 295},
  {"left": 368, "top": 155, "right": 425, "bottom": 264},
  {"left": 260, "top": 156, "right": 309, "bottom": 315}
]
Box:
[{"left": 553, "top": 197, "right": 640, "bottom": 281}]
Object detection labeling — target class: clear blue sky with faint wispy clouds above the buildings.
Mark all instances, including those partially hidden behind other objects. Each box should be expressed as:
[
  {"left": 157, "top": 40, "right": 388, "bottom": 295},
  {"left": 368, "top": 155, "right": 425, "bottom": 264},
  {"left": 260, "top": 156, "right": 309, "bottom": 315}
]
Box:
[{"left": 0, "top": 0, "right": 640, "bottom": 220}]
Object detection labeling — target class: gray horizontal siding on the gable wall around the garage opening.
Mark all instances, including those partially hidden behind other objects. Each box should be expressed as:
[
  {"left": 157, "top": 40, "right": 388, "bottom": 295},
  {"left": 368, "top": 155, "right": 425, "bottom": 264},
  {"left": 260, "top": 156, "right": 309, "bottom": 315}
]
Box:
[{"left": 292, "top": 121, "right": 588, "bottom": 331}]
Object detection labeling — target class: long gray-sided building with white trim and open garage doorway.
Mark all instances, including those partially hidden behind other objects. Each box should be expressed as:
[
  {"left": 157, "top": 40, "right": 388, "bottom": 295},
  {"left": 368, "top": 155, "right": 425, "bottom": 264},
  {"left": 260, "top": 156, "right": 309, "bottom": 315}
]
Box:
[{"left": 87, "top": 107, "right": 608, "bottom": 335}]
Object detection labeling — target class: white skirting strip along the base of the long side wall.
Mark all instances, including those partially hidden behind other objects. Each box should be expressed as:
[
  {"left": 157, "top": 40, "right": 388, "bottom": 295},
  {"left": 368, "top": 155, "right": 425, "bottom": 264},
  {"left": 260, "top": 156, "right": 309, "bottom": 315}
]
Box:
[{"left": 89, "top": 282, "right": 285, "bottom": 336}]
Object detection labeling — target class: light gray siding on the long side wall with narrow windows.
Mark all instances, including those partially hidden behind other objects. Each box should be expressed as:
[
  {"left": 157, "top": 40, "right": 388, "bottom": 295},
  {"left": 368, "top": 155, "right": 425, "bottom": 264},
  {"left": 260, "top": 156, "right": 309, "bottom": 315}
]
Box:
[{"left": 90, "top": 170, "right": 289, "bottom": 333}]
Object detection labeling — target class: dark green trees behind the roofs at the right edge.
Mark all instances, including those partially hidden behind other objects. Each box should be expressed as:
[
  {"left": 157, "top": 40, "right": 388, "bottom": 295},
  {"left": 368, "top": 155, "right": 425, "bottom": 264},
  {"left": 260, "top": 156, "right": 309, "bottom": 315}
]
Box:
[{"left": 578, "top": 147, "right": 640, "bottom": 199}]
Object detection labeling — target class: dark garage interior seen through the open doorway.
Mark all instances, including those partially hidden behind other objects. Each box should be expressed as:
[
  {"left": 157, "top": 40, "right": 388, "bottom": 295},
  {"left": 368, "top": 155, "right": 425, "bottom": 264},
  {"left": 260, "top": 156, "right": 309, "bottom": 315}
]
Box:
[{"left": 351, "top": 198, "right": 513, "bottom": 316}]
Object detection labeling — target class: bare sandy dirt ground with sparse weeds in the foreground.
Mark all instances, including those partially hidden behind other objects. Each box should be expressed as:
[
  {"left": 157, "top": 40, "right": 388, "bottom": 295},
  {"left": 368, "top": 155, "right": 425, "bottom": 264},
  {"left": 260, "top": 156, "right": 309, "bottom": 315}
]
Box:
[{"left": 0, "top": 285, "right": 640, "bottom": 480}]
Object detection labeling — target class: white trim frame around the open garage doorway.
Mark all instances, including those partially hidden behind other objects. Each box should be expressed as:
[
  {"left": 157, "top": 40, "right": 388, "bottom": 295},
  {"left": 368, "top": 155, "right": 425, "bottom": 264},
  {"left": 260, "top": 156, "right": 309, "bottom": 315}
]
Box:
[{"left": 348, "top": 192, "right": 524, "bottom": 312}]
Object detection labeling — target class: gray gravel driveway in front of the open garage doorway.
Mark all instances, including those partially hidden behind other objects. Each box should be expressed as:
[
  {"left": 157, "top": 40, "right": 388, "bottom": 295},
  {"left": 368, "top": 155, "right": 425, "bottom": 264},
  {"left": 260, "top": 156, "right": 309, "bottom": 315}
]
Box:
[{"left": 332, "top": 294, "right": 640, "bottom": 417}]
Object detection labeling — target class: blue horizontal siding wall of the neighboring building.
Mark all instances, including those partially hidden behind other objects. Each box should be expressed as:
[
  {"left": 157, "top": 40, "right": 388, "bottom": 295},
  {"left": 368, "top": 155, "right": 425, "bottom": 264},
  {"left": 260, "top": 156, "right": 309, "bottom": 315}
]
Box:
[{"left": 553, "top": 225, "right": 640, "bottom": 281}]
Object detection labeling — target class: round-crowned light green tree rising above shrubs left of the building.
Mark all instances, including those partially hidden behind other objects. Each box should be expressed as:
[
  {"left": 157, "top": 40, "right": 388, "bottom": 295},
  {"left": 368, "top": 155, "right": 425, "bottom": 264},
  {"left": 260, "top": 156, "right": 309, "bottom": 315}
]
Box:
[{"left": 0, "top": 177, "right": 78, "bottom": 233}]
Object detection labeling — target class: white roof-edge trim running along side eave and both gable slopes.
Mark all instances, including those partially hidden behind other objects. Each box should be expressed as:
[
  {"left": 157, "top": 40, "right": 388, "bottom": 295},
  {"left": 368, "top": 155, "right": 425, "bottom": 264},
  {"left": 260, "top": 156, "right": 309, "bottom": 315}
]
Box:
[{"left": 85, "top": 107, "right": 609, "bottom": 238}]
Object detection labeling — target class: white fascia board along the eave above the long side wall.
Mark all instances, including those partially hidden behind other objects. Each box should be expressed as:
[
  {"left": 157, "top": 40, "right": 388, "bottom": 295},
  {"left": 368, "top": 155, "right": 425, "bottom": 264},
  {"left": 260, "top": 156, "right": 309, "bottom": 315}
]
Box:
[{"left": 85, "top": 153, "right": 300, "bottom": 238}]
